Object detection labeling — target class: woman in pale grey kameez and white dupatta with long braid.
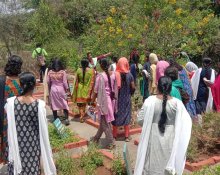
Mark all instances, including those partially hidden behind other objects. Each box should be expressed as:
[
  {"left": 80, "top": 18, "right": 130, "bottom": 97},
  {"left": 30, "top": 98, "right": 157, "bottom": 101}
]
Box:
[{"left": 134, "top": 76, "right": 192, "bottom": 175}]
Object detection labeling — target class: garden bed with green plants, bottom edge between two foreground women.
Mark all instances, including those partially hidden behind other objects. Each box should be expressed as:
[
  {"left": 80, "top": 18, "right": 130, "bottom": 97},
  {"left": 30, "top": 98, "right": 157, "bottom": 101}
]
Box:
[{"left": 55, "top": 144, "right": 125, "bottom": 175}]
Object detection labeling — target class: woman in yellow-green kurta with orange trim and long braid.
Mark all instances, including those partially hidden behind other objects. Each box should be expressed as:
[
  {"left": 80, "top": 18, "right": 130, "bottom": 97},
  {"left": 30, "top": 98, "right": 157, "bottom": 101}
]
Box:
[{"left": 72, "top": 59, "right": 95, "bottom": 122}]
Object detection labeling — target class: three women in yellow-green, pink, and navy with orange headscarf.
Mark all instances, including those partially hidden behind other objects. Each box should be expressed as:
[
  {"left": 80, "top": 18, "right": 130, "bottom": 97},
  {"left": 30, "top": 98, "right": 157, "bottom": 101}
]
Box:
[{"left": 72, "top": 57, "right": 135, "bottom": 148}]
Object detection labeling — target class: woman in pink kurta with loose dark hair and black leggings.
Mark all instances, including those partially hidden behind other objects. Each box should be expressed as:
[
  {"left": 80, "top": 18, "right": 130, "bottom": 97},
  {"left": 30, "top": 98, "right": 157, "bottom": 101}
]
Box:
[{"left": 47, "top": 59, "right": 69, "bottom": 125}]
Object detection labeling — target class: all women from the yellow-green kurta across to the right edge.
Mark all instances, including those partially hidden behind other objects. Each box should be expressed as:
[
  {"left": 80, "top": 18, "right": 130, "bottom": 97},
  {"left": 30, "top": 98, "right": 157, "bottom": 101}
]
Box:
[{"left": 73, "top": 51, "right": 220, "bottom": 175}]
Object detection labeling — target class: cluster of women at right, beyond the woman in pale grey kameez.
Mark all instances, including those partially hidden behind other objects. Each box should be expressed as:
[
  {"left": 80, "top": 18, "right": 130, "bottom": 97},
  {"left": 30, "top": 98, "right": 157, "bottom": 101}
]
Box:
[{"left": 139, "top": 53, "right": 220, "bottom": 118}]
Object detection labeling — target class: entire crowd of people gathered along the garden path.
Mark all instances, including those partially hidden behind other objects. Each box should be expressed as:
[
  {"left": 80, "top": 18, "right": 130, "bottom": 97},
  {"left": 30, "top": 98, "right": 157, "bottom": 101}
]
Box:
[{"left": 0, "top": 45, "right": 220, "bottom": 175}]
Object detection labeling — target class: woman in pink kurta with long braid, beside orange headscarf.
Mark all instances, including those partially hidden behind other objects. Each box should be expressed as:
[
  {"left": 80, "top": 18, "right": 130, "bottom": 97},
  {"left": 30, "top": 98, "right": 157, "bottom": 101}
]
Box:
[{"left": 92, "top": 59, "right": 117, "bottom": 149}]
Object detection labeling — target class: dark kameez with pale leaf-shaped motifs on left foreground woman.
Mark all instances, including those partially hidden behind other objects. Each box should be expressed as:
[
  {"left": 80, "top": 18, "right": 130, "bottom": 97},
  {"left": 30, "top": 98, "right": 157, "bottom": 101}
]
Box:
[{"left": 8, "top": 98, "right": 41, "bottom": 175}]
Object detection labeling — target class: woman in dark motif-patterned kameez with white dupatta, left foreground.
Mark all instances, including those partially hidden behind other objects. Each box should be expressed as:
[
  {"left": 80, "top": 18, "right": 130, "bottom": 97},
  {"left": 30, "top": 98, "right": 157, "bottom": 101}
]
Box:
[{"left": 5, "top": 72, "right": 56, "bottom": 175}]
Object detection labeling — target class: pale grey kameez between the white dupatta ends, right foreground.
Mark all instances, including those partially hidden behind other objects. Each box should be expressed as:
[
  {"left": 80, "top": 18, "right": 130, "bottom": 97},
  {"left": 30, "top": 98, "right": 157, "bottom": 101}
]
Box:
[{"left": 143, "top": 99, "right": 177, "bottom": 175}]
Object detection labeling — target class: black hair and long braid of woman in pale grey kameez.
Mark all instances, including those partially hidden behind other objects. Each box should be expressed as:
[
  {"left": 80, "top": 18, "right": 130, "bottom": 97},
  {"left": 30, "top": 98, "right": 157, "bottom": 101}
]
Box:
[{"left": 158, "top": 76, "right": 172, "bottom": 133}]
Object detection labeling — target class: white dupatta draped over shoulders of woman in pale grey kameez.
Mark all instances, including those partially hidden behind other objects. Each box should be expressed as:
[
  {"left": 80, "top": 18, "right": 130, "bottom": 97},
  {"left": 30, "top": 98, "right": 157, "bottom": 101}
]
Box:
[{"left": 134, "top": 96, "right": 192, "bottom": 175}]
